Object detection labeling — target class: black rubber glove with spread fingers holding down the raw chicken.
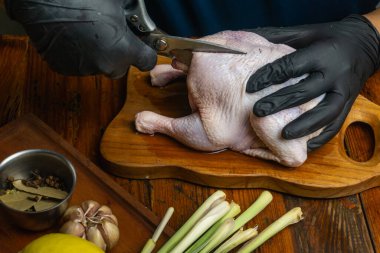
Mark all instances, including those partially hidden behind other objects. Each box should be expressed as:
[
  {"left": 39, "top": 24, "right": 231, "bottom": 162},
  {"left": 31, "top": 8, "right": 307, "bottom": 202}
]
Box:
[{"left": 246, "top": 15, "right": 379, "bottom": 151}]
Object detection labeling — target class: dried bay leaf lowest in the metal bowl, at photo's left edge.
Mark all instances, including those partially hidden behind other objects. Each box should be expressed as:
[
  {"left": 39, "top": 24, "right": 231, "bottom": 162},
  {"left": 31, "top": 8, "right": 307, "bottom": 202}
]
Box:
[{"left": 0, "top": 190, "right": 36, "bottom": 211}]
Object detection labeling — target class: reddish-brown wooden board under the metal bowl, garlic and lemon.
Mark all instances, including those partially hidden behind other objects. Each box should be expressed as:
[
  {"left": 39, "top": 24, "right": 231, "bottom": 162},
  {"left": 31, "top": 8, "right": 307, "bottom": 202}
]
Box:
[{"left": 0, "top": 115, "right": 172, "bottom": 253}]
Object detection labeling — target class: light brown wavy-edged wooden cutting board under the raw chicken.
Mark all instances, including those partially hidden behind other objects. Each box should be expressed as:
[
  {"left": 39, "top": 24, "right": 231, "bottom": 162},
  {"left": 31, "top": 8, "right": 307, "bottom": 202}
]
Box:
[{"left": 100, "top": 58, "right": 380, "bottom": 198}]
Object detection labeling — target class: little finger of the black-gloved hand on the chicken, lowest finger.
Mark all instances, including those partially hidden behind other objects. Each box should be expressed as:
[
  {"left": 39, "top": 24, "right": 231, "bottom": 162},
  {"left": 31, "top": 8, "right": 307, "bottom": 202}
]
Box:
[{"left": 307, "top": 103, "right": 350, "bottom": 152}]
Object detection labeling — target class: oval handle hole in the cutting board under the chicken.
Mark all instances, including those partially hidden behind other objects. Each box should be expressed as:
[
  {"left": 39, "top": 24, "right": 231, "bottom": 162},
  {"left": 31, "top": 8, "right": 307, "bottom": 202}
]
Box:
[{"left": 344, "top": 122, "right": 375, "bottom": 162}]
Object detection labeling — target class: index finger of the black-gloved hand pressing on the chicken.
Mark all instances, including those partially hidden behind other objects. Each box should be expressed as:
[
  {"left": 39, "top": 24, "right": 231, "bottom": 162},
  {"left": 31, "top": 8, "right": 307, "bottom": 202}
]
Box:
[{"left": 246, "top": 48, "right": 315, "bottom": 93}]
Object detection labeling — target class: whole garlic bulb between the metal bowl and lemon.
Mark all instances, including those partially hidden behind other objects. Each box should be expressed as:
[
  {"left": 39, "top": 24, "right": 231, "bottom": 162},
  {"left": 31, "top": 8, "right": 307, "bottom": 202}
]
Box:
[{"left": 59, "top": 200, "right": 119, "bottom": 251}]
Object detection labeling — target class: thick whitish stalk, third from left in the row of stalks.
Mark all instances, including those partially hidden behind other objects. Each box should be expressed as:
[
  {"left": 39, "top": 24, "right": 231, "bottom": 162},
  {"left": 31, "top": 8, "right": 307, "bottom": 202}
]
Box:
[{"left": 170, "top": 201, "right": 230, "bottom": 253}]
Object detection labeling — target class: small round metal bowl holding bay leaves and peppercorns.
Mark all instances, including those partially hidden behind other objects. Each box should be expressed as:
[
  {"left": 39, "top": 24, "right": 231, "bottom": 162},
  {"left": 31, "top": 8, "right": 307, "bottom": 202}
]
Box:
[{"left": 0, "top": 149, "right": 76, "bottom": 231}]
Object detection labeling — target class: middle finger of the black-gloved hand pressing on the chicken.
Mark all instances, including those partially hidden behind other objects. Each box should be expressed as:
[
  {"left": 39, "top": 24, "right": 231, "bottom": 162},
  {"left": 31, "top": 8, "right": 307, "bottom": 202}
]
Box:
[{"left": 253, "top": 72, "right": 326, "bottom": 117}]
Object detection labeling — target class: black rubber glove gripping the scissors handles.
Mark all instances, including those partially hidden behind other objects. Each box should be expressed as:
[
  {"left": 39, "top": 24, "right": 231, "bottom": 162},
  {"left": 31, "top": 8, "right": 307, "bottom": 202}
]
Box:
[{"left": 5, "top": 0, "right": 157, "bottom": 78}]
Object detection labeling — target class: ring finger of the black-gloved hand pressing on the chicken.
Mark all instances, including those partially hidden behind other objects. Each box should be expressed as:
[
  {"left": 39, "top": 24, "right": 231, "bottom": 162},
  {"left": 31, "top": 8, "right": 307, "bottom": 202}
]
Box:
[{"left": 282, "top": 93, "right": 346, "bottom": 140}]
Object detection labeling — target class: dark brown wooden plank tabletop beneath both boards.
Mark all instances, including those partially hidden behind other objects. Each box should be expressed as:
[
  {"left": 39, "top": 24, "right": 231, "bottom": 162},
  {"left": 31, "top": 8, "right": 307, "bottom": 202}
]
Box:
[{"left": 0, "top": 36, "right": 380, "bottom": 252}]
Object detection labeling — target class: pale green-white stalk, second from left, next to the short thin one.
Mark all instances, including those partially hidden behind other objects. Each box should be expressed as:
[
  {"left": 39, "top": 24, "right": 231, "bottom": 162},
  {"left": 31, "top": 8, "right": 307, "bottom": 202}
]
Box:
[{"left": 158, "top": 191, "right": 226, "bottom": 253}]
